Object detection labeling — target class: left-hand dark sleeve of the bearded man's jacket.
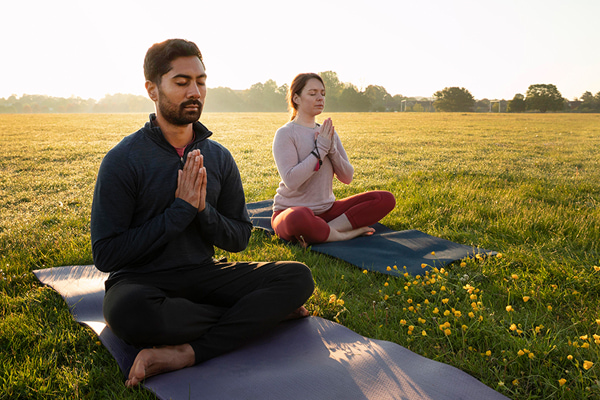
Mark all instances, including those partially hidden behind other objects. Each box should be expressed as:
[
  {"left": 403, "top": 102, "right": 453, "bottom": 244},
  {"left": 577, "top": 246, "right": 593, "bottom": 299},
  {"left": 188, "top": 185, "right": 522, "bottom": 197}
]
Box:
[{"left": 91, "top": 152, "right": 197, "bottom": 272}]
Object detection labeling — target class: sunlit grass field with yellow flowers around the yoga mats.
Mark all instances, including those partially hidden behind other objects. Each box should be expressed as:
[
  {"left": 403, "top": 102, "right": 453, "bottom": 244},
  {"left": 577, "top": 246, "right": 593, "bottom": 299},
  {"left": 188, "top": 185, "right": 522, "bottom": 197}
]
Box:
[{"left": 0, "top": 113, "right": 600, "bottom": 400}]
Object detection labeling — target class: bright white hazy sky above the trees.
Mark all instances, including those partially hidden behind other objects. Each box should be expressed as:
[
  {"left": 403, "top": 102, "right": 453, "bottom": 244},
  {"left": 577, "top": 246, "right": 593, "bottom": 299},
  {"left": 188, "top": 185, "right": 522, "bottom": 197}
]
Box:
[{"left": 0, "top": 0, "right": 600, "bottom": 101}]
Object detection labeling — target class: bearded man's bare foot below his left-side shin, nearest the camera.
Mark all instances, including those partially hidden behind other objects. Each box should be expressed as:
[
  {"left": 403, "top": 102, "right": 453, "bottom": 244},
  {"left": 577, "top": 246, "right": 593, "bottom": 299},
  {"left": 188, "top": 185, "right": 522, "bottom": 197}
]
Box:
[{"left": 125, "top": 343, "right": 196, "bottom": 387}]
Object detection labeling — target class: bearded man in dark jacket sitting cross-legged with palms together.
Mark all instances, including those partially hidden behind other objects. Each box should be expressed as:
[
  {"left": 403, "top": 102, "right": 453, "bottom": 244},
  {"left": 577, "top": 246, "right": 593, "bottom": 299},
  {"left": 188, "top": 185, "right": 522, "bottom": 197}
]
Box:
[{"left": 91, "top": 39, "right": 314, "bottom": 386}]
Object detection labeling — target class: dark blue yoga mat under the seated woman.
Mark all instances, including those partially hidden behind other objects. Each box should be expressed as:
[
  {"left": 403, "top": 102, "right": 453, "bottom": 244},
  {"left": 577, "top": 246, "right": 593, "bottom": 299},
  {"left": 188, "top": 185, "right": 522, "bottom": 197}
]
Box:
[{"left": 246, "top": 200, "right": 497, "bottom": 275}]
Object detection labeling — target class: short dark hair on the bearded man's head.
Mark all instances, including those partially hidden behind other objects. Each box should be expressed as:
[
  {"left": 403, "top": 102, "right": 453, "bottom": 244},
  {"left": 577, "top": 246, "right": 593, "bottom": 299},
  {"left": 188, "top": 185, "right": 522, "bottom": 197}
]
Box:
[{"left": 144, "top": 39, "right": 204, "bottom": 84}]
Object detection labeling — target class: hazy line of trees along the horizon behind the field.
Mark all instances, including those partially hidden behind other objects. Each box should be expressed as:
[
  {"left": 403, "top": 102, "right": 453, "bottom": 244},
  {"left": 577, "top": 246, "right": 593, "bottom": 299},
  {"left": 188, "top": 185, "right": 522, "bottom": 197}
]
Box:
[{"left": 0, "top": 71, "right": 600, "bottom": 113}]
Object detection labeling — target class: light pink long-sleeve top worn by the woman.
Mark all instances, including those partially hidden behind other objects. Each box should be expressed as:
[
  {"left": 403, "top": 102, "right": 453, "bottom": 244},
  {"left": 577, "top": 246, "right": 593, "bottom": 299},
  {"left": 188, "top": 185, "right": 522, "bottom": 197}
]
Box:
[{"left": 273, "top": 122, "right": 354, "bottom": 215}]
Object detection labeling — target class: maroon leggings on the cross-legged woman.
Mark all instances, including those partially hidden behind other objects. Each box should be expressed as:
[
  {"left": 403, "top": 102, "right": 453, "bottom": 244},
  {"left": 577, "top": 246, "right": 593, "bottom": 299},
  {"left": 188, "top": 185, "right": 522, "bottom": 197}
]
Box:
[{"left": 271, "top": 190, "right": 396, "bottom": 243}]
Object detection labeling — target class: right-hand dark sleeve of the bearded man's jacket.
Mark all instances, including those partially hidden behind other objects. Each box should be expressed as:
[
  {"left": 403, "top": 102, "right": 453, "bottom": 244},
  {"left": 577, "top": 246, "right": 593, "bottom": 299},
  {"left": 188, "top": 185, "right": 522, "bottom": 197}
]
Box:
[{"left": 196, "top": 150, "right": 252, "bottom": 252}]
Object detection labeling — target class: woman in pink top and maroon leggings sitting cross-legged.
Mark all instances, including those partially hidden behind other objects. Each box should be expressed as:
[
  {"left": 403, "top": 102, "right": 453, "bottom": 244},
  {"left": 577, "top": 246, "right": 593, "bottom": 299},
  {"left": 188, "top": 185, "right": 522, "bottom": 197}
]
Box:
[{"left": 271, "top": 73, "right": 396, "bottom": 245}]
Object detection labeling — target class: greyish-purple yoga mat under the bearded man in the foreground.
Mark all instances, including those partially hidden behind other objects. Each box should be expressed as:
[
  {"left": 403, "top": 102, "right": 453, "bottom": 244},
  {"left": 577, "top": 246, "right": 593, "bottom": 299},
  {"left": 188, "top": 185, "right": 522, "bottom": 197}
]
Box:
[{"left": 33, "top": 265, "right": 507, "bottom": 400}]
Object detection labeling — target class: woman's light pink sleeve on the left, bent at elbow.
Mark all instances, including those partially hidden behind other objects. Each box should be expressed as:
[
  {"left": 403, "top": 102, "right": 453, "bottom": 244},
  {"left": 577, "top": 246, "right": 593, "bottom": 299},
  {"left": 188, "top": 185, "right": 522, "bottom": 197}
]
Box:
[{"left": 273, "top": 130, "right": 325, "bottom": 190}]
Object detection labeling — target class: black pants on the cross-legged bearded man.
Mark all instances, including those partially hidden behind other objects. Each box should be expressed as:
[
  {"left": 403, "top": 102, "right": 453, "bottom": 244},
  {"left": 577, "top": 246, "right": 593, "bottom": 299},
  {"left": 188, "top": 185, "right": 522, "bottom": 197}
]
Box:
[{"left": 103, "top": 261, "right": 314, "bottom": 363}]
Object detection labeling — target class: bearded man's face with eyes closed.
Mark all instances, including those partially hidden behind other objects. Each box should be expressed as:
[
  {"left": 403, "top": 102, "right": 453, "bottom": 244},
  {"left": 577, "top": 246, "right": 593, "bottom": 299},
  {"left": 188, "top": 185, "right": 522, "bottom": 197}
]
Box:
[{"left": 152, "top": 56, "right": 206, "bottom": 126}]
